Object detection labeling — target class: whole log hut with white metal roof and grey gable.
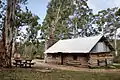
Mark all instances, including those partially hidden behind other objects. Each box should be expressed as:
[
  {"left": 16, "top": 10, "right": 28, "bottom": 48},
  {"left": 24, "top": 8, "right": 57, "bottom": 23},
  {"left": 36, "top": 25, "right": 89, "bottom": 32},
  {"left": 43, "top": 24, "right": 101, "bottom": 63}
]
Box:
[{"left": 44, "top": 35, "right": 114, "bottom": 67}]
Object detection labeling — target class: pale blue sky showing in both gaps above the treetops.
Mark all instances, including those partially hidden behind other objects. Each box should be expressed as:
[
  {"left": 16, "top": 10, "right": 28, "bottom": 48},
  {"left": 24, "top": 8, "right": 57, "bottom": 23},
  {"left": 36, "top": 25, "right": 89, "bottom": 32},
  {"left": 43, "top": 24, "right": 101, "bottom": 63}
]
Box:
[{"left": 27, "top": 0, "right": 120, "bottom": 23}]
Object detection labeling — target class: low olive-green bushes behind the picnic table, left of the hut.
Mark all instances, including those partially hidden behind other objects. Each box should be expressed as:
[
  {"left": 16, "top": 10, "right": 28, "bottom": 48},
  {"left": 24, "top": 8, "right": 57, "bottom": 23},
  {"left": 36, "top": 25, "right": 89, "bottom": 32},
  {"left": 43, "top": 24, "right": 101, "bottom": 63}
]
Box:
[{"left": 18, "top": 41, "right": 44, "bottom": 58}]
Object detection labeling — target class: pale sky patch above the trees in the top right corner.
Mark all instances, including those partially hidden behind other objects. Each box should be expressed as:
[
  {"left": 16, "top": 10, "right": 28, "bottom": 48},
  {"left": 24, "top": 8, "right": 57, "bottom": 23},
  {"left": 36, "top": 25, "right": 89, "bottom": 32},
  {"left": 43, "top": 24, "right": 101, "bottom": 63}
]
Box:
[{"left": 88, "top": 0, "right": 120, "bottom": 13}]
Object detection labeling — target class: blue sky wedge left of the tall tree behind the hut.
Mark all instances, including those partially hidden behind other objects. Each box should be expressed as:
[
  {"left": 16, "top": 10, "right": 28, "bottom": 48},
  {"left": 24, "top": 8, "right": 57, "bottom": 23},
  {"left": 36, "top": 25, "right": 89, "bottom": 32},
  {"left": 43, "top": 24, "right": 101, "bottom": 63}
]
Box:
[{"left": 27, "top": 0, "right": 50, "bottom": 23}]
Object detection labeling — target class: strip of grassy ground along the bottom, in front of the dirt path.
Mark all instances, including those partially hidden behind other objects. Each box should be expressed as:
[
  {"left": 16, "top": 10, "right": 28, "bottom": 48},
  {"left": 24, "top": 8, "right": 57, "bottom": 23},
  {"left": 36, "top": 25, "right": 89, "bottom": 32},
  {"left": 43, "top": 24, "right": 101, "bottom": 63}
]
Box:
[{"left": 0, "top": 69, "right": 120, "bottom": 80}]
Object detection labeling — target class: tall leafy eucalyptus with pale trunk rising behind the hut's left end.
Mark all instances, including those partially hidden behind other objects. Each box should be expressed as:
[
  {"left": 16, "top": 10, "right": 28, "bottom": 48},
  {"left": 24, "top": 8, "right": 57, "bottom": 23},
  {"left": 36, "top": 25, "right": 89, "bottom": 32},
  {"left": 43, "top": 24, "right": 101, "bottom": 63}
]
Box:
[{"left": 41, "top": 0, "right": 74, "bottom": 46}]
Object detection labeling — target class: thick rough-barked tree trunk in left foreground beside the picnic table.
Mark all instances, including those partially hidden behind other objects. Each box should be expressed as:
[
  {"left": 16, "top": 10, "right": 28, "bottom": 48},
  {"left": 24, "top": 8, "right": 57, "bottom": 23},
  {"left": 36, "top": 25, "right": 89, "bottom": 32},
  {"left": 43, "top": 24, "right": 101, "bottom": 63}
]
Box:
[{"left": 4, "top": 0, "right": 16, "bottom": 67}]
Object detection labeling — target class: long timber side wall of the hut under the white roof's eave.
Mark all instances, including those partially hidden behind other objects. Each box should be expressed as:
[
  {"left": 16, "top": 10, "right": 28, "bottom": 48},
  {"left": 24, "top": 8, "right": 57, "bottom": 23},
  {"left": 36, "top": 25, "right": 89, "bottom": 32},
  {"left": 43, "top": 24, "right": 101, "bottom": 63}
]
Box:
[{"left": 47, "top": 53, "right": 88, "bottom": 66}]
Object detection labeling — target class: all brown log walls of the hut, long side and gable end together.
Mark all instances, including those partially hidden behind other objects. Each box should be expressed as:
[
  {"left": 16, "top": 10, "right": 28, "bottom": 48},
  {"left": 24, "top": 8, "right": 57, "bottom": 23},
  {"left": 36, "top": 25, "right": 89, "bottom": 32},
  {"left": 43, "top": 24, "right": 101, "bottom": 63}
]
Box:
[{"left": 47, "top": 53, "right": 113, "bottom": 67}]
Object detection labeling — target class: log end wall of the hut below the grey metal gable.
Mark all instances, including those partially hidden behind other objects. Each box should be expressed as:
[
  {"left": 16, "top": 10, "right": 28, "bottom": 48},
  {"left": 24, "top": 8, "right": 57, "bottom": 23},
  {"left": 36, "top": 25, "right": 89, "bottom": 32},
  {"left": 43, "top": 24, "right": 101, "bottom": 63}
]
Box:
[{"left": 89, "top": 53, "right": 113, "bottom": 67}]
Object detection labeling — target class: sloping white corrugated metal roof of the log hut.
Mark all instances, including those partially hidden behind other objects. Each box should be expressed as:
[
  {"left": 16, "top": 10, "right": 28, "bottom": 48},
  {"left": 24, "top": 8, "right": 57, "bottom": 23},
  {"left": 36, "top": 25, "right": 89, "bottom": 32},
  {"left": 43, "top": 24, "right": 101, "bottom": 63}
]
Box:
[{"left": 45, "top": 35, "right": 103, "bottom": 53}]
